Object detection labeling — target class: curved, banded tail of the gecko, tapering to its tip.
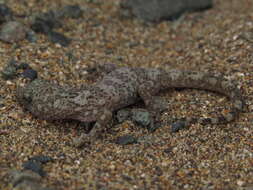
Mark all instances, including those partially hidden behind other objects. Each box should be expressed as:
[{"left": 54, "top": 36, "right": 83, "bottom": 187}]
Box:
[{"left": 163, "top": 70, "right": 244, "bottom": 124}]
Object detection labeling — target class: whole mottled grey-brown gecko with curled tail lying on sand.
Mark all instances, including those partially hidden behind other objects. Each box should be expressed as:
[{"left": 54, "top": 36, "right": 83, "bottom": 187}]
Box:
[{"left": 16, "top": 64, "right": 244, "bottom": 145}]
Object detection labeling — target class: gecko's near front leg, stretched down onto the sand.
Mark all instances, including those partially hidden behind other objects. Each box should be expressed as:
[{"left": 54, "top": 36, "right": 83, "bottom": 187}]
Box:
[{"left": 73, "top": 109, "right": 112, "bottom": 147}]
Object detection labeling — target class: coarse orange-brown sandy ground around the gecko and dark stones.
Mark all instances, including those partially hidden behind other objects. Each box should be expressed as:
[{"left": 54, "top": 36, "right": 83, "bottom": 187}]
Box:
[{"left": 0, "top": 0, "right": 253, "bottom": 190}]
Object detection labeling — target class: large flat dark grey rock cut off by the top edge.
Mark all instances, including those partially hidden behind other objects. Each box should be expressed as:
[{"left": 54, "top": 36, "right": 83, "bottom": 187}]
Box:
[{"left": 121, "top": 0, "right": 212, "bottom": 22}]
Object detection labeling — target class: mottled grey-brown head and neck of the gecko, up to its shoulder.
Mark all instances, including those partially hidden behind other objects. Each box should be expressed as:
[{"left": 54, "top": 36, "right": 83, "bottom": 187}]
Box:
[{"left": 17, "top": 79, "right": 105, "bottom": 122}]
